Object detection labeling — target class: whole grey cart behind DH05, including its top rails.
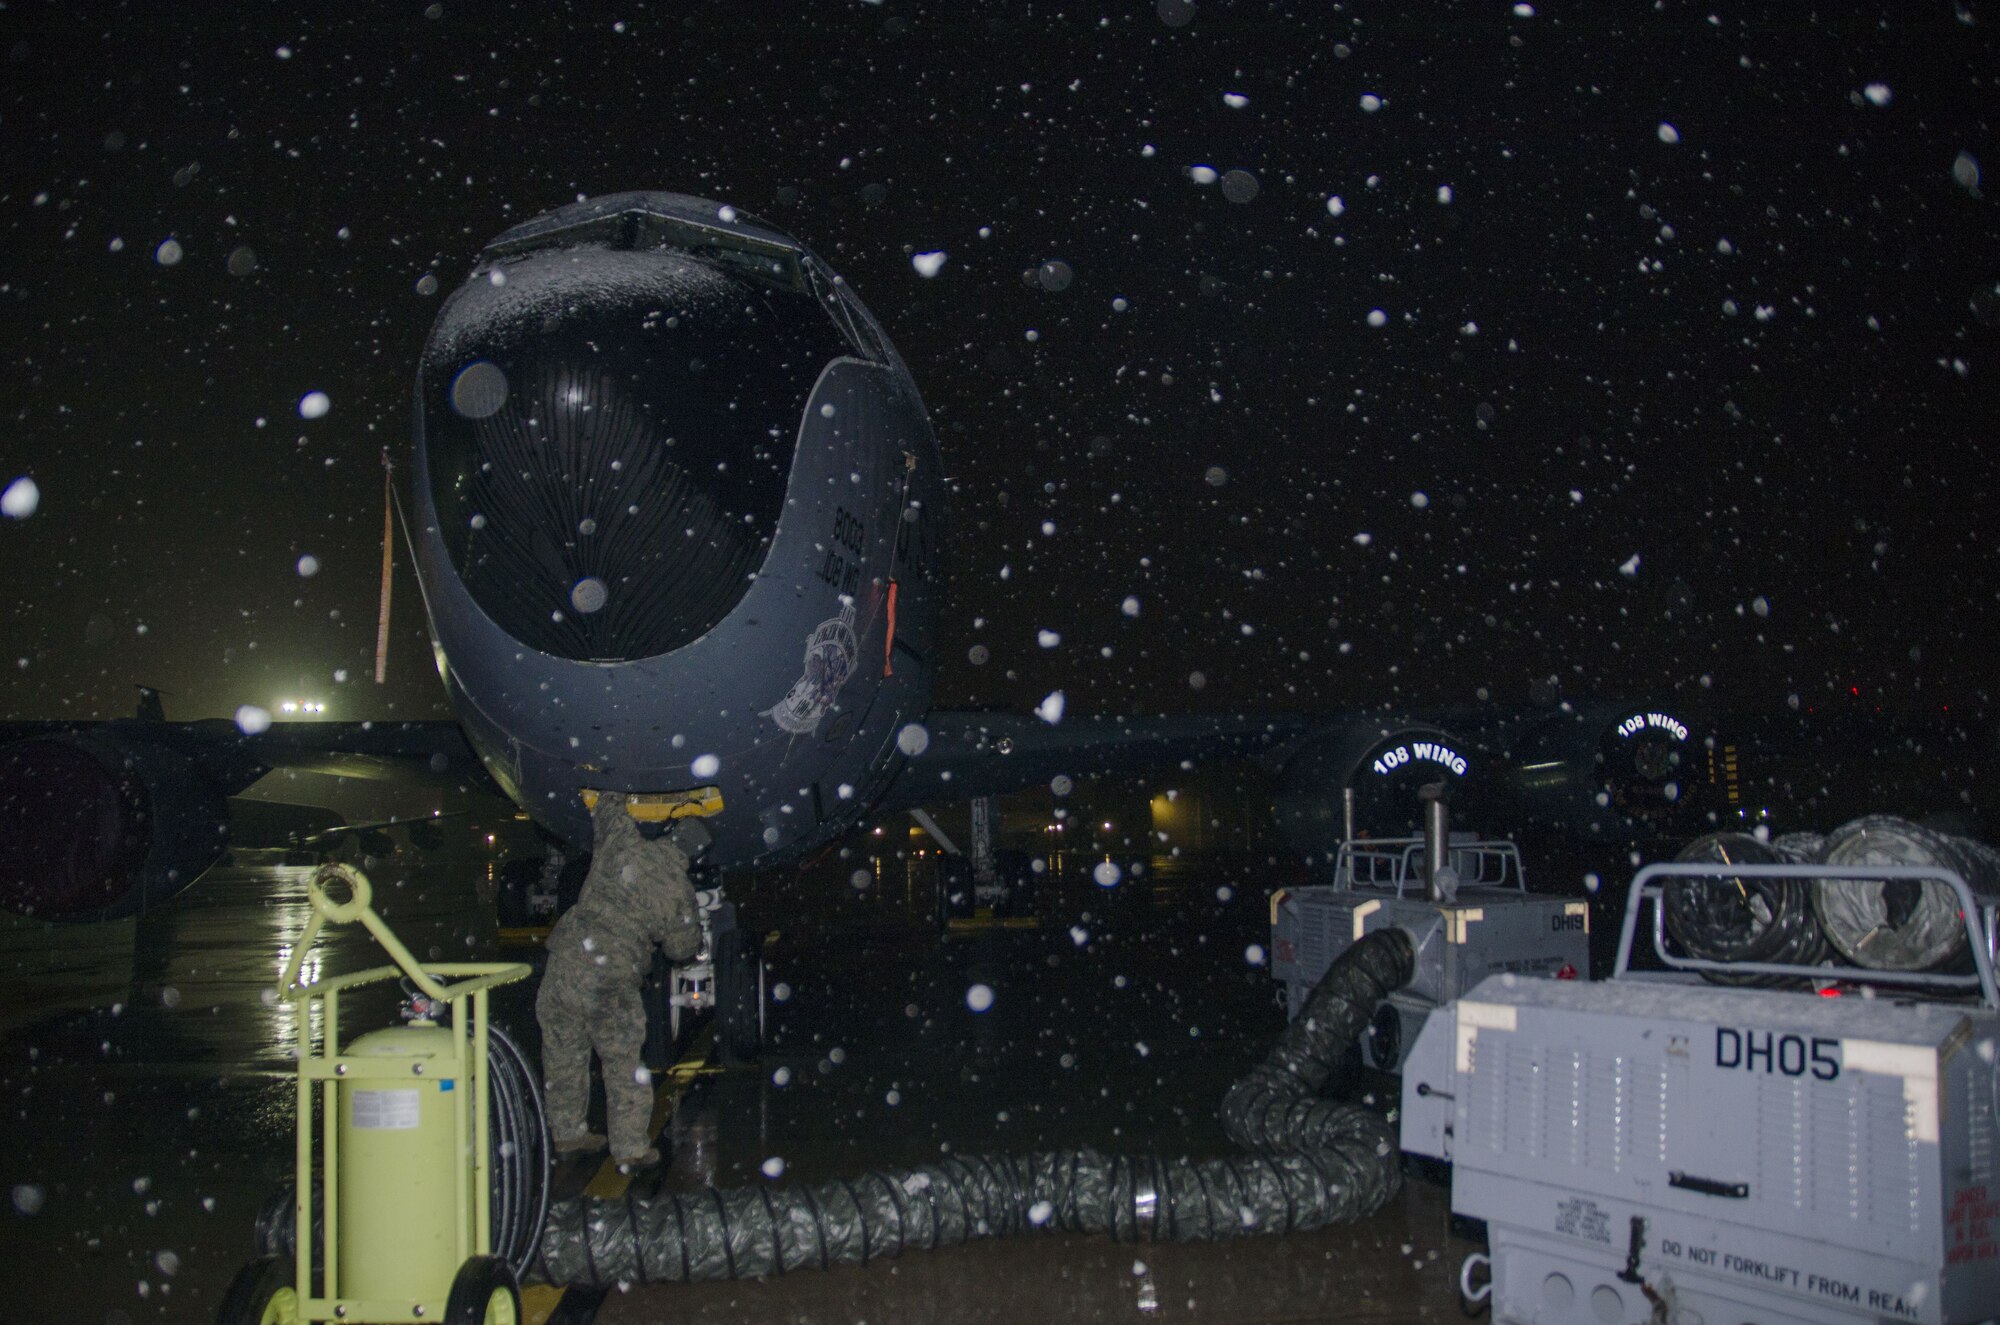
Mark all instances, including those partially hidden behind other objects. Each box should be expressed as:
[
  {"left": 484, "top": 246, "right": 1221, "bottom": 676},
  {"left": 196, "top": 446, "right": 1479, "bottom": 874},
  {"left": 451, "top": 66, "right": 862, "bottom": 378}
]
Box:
[{"left": 1270, "top": 833, "right": 1590, "bottom": 1071}]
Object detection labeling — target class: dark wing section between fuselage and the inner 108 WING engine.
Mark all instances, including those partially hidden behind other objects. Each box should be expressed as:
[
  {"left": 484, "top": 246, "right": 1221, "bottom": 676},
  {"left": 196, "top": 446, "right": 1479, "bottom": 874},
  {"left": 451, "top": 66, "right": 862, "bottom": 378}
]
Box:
[{"left": 878, "top": 711, "right": 1328, "bottom": 813}]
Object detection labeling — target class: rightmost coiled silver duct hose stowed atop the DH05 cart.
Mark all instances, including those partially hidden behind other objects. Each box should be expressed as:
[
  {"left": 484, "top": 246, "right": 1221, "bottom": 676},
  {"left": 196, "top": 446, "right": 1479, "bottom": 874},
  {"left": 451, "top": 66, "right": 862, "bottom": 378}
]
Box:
[{"left": 1812, "top": 815, "right": 2000, "bottom": 971}]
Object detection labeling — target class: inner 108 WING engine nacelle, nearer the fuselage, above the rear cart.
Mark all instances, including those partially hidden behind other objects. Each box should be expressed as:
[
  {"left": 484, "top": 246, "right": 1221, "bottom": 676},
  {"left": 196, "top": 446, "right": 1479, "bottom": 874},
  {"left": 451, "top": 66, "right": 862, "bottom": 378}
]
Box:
[{"left": 1272, "top": 717, "right": 1480, "bottom": 869}]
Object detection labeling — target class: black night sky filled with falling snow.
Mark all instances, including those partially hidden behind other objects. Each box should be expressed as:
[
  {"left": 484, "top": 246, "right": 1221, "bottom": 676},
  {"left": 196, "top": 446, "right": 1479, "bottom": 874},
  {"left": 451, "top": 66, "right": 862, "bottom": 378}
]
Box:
[{"left": 0, "top": 0, "right": 2000, "bottom": 736}]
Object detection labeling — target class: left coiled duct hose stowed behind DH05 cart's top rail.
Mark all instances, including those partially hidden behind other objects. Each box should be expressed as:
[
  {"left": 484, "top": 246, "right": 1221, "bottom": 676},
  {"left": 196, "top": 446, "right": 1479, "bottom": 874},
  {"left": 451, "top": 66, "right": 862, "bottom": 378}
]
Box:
[{"left": 1664, "top": 833, "right": 1826, "bottom": 989}]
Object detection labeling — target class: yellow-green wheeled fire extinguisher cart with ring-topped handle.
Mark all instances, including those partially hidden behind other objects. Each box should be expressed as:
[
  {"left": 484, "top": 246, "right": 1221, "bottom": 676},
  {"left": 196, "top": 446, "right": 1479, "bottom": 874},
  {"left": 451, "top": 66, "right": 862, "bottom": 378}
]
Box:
[{"left": 218, "top": 865, "right": 546, "bottom": 1325}]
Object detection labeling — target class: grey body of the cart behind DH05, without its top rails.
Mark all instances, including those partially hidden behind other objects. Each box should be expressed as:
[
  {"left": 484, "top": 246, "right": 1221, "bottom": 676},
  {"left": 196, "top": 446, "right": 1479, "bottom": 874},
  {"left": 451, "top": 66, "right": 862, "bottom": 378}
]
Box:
[{"left": 1272, "top": 852, "right": 1590, "bottom": 1071}]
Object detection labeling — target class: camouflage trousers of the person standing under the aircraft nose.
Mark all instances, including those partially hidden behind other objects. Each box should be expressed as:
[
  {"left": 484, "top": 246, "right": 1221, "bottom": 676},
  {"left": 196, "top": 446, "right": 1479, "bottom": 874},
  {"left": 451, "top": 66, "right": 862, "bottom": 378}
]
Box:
[{"left": 534, "top": 953, "right": 652, "bottom": 1157}]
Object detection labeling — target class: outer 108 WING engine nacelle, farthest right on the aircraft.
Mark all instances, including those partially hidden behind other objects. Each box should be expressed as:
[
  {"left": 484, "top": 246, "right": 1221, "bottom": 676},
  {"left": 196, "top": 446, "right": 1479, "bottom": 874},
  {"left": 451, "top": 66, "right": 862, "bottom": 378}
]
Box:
[{"left": 1482, "top": 705, "right": 1722, "bottom": 841}]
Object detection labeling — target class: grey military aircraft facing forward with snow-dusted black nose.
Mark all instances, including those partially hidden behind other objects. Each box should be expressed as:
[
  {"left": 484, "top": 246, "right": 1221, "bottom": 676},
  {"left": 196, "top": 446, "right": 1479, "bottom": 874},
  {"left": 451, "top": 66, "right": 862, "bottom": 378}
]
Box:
[{"left": 0, "top": 192, "right": 1714, "bottom": 976}]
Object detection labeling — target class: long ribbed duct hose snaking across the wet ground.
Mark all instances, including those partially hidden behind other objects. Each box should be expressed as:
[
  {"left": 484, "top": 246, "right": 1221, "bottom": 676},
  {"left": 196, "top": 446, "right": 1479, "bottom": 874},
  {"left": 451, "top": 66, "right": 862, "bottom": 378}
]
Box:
[{"left": 528, "top": 929, "right": 1416, "bottom": 1287}]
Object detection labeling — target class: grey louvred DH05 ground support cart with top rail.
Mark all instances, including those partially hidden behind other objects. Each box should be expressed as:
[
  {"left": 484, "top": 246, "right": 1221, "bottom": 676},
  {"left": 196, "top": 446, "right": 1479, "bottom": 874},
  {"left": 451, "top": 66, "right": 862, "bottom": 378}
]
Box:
[{"left": 1402, "top": 863, "right": 2000, "bottom": 1325}]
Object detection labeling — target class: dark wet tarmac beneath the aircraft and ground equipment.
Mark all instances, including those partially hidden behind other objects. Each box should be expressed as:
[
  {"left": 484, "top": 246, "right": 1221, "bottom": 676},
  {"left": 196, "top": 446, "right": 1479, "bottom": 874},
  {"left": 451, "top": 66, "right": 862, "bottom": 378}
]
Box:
[{"left": 0, "top": 853, "right": 1472, "bottom": 1325}]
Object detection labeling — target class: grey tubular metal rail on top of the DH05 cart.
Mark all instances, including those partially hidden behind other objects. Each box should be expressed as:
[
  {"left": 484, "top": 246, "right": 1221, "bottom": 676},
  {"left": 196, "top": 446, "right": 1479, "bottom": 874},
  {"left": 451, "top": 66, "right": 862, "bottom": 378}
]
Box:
[{"left": 1612, "top": 861, "right": 2000, "bottom": 1009}]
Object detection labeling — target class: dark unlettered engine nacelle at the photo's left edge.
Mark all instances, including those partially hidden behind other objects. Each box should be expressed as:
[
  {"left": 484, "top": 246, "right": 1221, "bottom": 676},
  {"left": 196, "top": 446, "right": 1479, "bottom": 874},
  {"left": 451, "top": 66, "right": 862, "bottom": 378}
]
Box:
[{"left": 0, "top": 733, "right": 228, "bottom": 921}]
